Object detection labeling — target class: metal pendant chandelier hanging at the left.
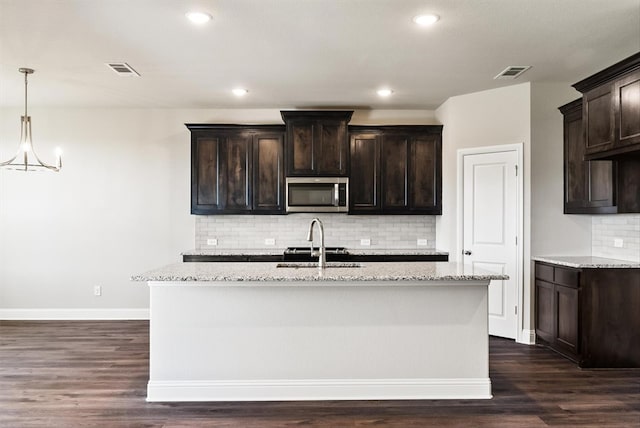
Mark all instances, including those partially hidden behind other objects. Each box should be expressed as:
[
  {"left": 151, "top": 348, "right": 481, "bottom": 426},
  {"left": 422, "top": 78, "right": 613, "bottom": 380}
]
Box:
[{"left": 0, "top": 68, "right": 62, "bottom": 172}]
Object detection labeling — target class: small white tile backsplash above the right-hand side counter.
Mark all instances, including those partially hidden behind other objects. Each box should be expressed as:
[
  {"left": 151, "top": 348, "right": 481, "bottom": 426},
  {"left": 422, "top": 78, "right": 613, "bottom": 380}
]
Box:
[{"left": 591, "top": 214, "right": 640, "bottom": 262}]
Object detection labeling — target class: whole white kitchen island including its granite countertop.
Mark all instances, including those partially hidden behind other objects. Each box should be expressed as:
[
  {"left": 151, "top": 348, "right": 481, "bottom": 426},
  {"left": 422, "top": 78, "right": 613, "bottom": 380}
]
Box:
[{"left": 132, "top": 262, "right": 506, "bottom": 401}]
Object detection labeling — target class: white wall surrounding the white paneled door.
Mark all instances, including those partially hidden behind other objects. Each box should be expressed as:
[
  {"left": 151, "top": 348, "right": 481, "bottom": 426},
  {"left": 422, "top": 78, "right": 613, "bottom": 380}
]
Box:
[{"left": 436, "top": 83, "right": 591, "bottom": 338}]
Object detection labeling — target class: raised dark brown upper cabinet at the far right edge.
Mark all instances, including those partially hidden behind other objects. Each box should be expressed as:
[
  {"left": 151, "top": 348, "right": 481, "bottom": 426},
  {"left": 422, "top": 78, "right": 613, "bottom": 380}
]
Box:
[{"left": 573, "top": 53, "right": 640, "bottom": 160}]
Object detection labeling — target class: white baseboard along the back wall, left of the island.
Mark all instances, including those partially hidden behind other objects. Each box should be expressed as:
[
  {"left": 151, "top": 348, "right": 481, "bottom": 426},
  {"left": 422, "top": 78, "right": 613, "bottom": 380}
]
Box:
[{"left": 0, "top": 308, "right": 149, "bottom": 320}]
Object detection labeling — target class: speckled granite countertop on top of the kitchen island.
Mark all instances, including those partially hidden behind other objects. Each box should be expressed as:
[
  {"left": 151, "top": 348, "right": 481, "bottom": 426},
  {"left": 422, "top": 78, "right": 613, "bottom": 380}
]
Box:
[{"left": 131, "top": 262, "right": 508, "bottom": 285}]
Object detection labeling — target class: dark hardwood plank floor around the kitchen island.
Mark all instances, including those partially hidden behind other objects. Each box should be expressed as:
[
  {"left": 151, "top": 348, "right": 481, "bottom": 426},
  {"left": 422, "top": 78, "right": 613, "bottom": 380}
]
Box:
[{"left": 0, "top": 321, "right": 640, "bottom": 428}]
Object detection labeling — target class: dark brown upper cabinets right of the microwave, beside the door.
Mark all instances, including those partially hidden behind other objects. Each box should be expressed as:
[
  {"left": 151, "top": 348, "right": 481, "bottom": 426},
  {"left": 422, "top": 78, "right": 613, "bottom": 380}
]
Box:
[{"left": 349, "top": 125, "right": 442, "bottom": 214}]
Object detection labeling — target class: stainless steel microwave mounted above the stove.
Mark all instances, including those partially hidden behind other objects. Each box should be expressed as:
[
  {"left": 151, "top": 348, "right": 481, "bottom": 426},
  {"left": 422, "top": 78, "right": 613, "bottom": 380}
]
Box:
[{"left": 286, "top": 177, "right": 349, "bottom": 213}]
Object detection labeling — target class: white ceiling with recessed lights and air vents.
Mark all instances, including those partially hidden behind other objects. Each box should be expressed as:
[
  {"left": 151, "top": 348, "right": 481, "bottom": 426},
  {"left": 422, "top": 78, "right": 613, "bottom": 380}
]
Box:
[{"left": 0, "top": 0, "right": 640, "bottom": 109}]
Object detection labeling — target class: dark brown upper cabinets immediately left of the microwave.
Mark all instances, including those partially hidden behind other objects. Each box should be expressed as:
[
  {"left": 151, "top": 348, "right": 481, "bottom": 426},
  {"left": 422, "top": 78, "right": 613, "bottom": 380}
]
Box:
[{"left": 187, "top": 124, "right": 284, "bottom": 214}]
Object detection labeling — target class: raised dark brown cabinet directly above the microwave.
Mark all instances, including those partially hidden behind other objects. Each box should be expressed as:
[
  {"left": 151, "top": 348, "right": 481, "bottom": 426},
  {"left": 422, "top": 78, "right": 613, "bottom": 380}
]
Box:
[{"left": 281, "top": 111, "right": 353, "bottom": 176}]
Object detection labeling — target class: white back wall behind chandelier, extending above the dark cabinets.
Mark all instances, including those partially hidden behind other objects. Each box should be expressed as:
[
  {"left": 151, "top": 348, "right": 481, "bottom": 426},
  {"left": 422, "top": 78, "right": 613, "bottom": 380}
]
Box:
[{"left": 0, "top": 107, "right": 436, "bottom": 318}]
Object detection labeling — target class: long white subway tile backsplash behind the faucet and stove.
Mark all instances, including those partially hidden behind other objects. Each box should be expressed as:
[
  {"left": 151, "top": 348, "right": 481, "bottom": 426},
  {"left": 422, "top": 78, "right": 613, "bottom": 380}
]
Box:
[{"left": 195, "top": 213, "right": 436, "bottom": 250}]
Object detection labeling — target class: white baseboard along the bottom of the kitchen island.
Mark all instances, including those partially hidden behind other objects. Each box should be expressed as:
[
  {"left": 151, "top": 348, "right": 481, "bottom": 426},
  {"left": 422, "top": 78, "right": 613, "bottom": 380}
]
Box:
[{"left": 147, "top": 378, "right": 492, "bottom": 402}]
